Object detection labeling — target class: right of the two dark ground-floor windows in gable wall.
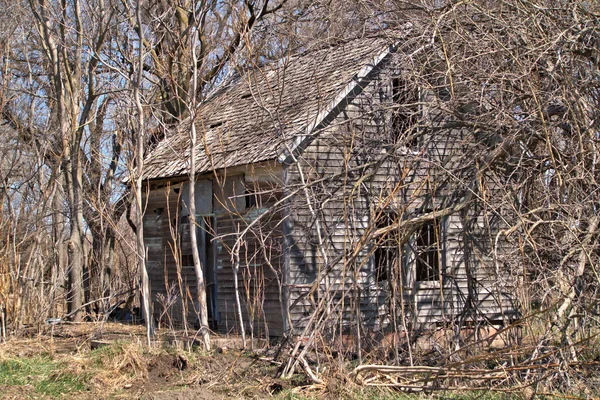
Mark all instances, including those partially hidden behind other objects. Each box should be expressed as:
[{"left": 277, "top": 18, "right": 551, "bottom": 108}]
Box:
[{"left": 415, "top": 221, "right": 440, "bottom": 282}]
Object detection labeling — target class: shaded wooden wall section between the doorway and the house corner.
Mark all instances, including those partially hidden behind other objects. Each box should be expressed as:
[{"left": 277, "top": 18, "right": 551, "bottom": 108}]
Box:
[{"left": 213, "top": 164, "right": 283, "bottom": 336}]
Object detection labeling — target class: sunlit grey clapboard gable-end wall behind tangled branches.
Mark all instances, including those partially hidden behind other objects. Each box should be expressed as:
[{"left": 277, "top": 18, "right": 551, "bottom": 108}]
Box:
[{"left": 287, "top": 52, "right": 516, "bottom": 332}]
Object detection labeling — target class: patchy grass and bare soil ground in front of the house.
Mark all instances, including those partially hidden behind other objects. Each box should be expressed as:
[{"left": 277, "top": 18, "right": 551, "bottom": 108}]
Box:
[{"left": 0, "top": 323, "right": 596, "bottom": 400}]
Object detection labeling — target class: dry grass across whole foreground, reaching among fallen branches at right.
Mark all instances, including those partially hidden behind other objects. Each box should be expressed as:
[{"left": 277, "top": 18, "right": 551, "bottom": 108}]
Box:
[{"left": 0, "top": 324, "right": 600, "bottom": 400}]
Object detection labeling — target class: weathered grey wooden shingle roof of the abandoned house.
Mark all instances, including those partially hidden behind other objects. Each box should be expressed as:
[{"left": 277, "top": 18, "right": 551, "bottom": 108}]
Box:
[{"left": 143, "top": 38, "right": 389, "bottom": 179}]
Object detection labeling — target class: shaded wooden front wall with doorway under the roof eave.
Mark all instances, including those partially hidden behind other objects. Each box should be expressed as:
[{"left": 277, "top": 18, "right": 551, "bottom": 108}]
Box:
[{"left": 144, "top": 163, "right": 283, "bottom": 336}]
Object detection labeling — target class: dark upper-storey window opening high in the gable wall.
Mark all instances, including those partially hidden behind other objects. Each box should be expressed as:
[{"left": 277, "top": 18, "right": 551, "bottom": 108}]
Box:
[{"left": 392, "top": 78, "right": 419, "bottom": 148}]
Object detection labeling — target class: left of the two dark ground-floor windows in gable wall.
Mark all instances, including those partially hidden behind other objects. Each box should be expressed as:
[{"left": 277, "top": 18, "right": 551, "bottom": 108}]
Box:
[{"left": 373, "top": 212, "right": 402, "bottom": 282}]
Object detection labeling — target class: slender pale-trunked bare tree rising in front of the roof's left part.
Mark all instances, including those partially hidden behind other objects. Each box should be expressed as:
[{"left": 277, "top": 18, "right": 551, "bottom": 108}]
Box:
[{"left": 139, "top": 0, "right": 285, "bottom": 348}]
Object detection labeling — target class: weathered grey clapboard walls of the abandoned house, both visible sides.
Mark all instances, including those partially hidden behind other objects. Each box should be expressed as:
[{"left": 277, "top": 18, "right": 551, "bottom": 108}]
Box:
[{"left": 144, "top": 43, "right": 517, "bottom": 335}]
